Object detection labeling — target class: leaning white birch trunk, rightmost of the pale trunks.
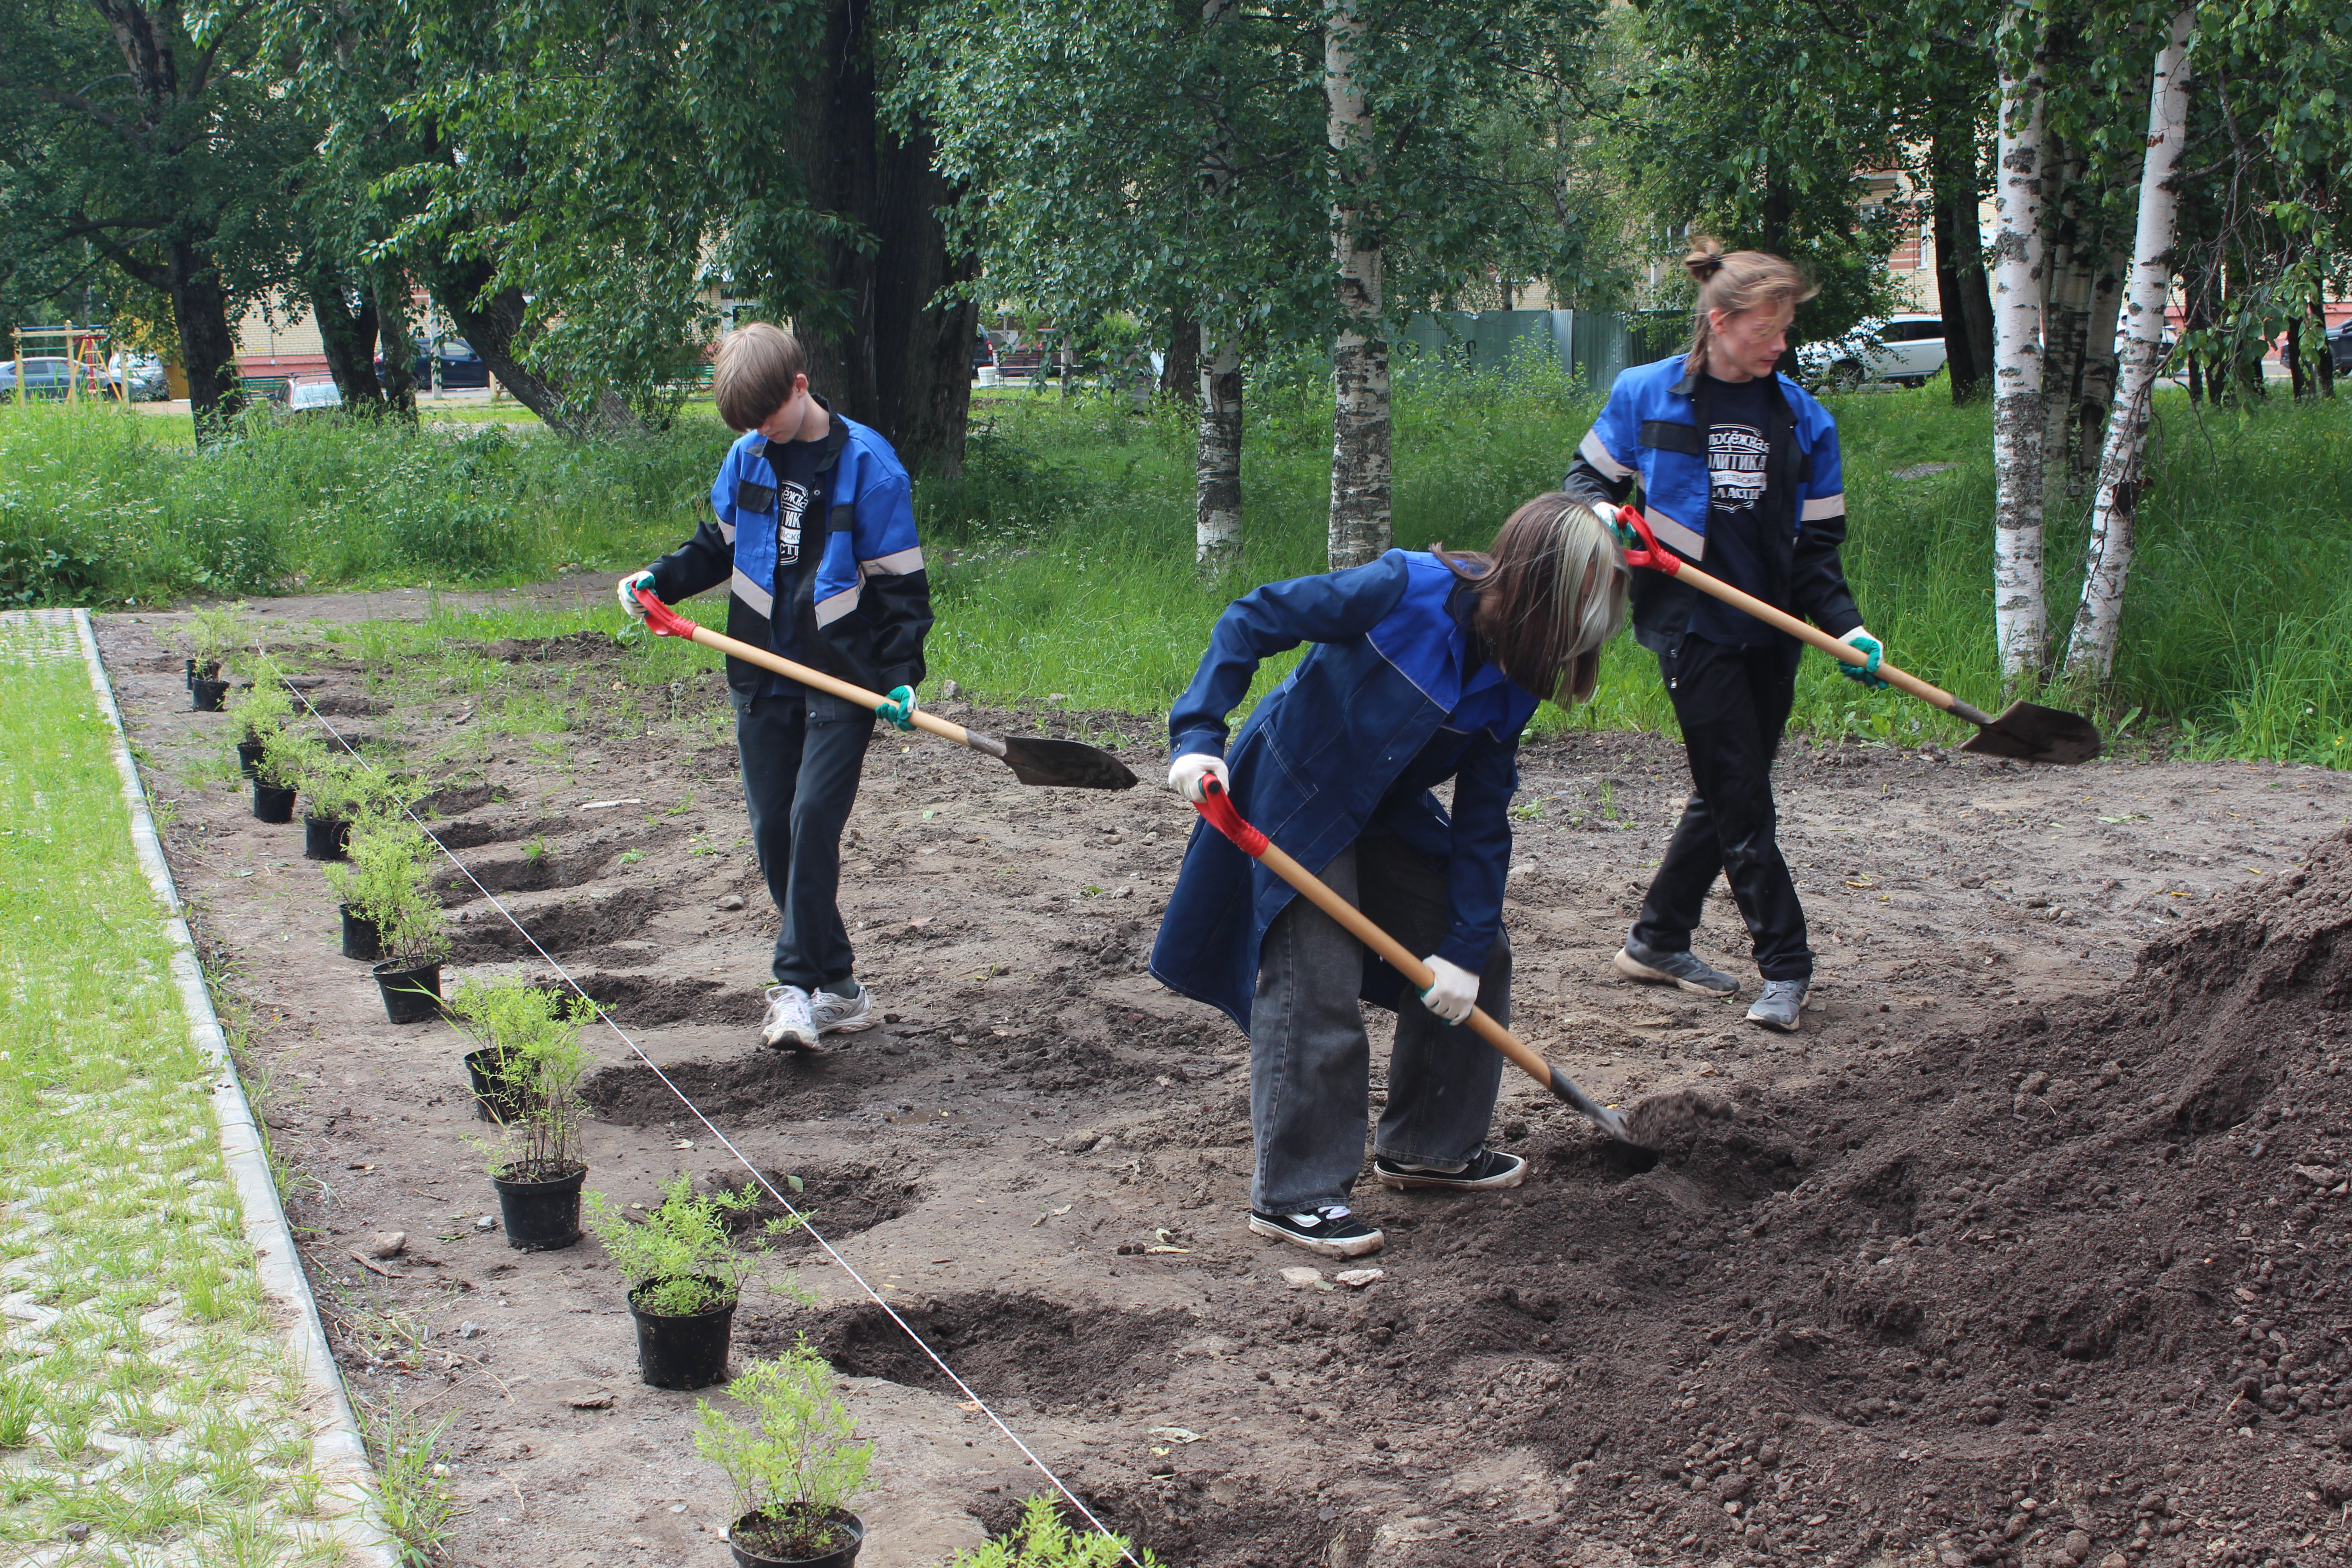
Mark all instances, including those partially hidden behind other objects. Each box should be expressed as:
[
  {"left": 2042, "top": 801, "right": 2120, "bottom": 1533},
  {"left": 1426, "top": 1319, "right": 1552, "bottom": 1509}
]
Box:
[{"left": 2065, "top": 5, "right": 2197, "bottom": 682}]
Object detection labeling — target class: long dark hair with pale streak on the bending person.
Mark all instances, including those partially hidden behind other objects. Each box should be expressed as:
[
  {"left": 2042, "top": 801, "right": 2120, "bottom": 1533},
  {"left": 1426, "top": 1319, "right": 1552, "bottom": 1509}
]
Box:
[{"left": 1430, "top": 491, "right": 1632, "bottom": 708}]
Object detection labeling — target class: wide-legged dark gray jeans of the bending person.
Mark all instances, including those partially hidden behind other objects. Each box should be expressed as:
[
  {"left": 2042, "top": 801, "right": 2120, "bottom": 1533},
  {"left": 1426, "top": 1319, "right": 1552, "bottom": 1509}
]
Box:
[{"left": 1249, "top": 837, "right": 1510, "bottom": 1213}]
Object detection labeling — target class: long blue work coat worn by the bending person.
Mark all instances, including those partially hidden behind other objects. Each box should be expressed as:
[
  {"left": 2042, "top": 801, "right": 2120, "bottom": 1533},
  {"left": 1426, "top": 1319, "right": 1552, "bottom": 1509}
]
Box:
[{"left": 1150, "top": 550, "right": 1538, "bottom": 1029}]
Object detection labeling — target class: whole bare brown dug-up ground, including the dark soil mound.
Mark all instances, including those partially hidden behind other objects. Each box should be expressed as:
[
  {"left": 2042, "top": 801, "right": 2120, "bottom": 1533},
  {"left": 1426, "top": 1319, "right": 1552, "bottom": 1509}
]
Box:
[{"left": 101, "top": 618, "right": 2352, "bottom": 1568}]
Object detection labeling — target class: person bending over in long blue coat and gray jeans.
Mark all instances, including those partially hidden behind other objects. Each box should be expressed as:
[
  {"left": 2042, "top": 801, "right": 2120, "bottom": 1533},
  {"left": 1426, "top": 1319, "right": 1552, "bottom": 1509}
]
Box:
[{"left": 1152, "top": 494, "right": 1625, "bottom": 1258}]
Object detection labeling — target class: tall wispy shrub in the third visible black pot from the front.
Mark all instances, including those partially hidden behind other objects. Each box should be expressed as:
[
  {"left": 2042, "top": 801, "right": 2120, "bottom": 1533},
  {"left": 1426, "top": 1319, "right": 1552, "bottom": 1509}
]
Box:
[{"left": 449, "top": 978, "right": 595, "bottom": 1253}]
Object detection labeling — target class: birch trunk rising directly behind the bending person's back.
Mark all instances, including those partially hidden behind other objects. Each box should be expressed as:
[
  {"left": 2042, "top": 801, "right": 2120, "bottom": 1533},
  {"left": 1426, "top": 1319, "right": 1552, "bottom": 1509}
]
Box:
[{"left": 1324, "top": 0, "right": 1390, "bottom": 571}]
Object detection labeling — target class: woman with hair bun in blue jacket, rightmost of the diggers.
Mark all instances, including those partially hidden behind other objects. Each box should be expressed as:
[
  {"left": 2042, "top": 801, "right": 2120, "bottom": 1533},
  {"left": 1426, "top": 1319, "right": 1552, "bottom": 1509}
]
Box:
[{"left": 1562, "top": 240, "right": 1886, "bottom": 1032}]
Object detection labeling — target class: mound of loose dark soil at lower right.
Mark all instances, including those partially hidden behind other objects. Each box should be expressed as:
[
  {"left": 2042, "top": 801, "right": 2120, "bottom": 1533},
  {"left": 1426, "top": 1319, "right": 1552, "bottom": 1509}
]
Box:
[{"left": 1354, "top": 839, "right": 2352, "bottom": 1566}]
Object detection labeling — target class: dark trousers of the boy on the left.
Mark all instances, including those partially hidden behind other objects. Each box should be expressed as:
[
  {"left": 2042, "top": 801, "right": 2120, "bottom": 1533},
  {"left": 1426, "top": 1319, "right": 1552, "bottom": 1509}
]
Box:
[{"left": 734, "top": 686, "right": 875, "bottom": 997}]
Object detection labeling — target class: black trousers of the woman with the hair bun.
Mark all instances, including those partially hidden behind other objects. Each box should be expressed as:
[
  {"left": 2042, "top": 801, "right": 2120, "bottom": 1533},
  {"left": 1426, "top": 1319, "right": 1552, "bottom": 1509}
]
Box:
[{"left": 1632, "top": 632, "right": 1813, "bottom": 980}]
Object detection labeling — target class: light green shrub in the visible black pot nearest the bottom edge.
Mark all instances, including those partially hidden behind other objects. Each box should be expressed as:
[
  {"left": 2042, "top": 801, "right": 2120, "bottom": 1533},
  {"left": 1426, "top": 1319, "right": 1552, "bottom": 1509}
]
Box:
[{"left": 694, "top": 1335, "right": 875, "bottom": 1568}]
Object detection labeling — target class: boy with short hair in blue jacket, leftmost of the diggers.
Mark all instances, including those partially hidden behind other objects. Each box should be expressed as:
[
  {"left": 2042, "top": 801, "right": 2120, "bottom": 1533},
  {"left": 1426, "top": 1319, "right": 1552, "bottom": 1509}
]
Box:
[{"left": 621, "top": 322, "right": 931, "bottom": 1051}]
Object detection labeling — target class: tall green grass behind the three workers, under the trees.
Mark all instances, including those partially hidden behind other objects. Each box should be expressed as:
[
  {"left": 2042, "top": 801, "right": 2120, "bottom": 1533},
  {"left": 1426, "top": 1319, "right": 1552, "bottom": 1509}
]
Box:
[{"left": 0, "top": 360, "right": 2352, "bottom": 766}]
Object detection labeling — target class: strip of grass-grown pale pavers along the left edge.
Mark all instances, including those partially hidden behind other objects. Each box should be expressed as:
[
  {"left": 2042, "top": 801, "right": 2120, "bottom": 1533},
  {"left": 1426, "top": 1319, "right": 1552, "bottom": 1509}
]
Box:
[{"left": 0, "top": 625, "right": 376, "bottom": 1568}]
